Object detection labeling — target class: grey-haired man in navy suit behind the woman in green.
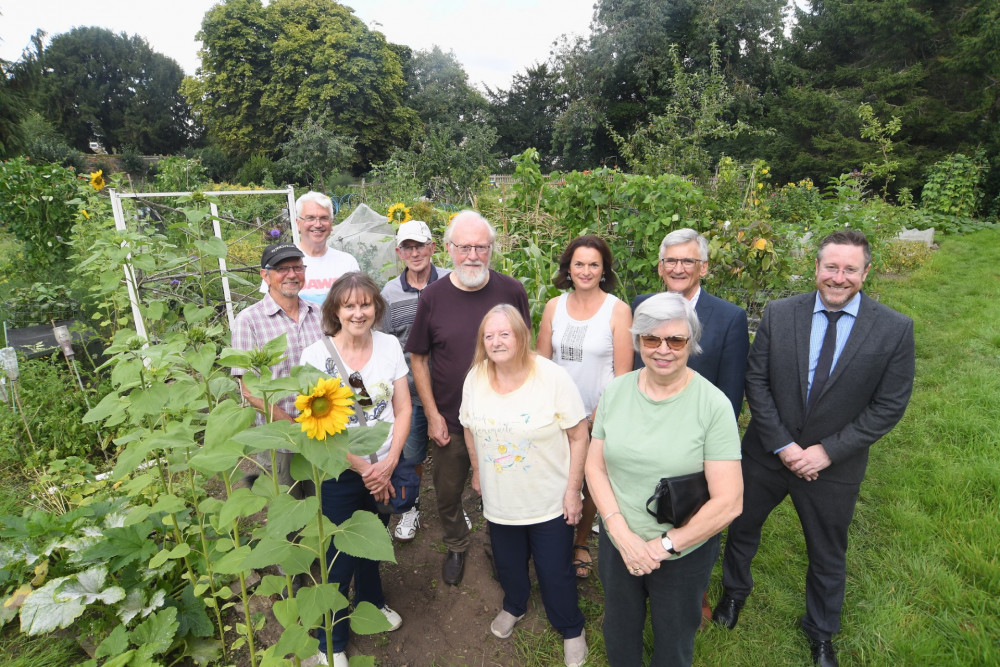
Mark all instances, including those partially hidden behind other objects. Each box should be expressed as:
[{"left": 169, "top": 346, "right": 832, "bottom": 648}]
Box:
[{"left": 632, "top": 228, "right": 750, "bottom": 417}]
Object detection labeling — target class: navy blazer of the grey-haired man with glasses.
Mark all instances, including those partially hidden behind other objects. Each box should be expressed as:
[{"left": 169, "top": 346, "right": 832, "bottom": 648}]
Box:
[{"left": 632, "top": 289, "right": 750, "bottom": 417}]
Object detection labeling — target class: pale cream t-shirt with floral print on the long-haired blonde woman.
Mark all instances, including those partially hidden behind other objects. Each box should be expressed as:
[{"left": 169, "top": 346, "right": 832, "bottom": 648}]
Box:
[{"left": 459, "top": 356, "right": 586, "bottom": 525}]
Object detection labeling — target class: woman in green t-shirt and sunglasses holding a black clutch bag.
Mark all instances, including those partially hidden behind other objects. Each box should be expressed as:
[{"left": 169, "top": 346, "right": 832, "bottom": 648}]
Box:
[{"left": 586, "top": 293, "right": 743, "bottom": 667}]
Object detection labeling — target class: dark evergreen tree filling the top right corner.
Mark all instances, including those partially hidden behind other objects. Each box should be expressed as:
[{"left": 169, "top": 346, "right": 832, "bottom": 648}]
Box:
[{"left": 766, "top": 0, "right": 1000, "bottom": 197}]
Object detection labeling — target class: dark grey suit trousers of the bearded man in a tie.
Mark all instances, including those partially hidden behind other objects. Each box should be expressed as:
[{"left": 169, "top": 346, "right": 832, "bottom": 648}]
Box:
[{"left": 722, "top": 457, "right": 861, "bottom": 641}]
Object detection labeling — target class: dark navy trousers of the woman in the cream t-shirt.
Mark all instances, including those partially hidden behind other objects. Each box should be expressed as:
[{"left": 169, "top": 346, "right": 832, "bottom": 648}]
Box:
[{"left": 489, "top": 516, "right": 583, "bottom": 639}]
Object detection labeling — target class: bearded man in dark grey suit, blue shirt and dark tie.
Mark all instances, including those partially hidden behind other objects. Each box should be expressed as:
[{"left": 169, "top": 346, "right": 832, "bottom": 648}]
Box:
[{"left": 712, "top": 229, "right": 914, "bottom": 667}]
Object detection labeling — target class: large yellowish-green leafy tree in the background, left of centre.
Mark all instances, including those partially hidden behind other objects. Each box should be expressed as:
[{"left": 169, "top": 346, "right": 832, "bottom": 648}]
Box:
[{"left": 184, "top": 0, "right": 417, "bottom": 169}]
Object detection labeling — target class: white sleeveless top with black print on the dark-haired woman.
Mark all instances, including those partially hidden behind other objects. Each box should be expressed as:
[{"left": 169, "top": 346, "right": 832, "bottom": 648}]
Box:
[{"left": 552, "top": 294, "right": 618, "bottom": 415}]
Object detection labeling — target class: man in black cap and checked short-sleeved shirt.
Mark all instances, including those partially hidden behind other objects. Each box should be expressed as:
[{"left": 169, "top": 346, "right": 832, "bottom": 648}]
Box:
[{"left": 232, "top": 243, "right": 323, "bottom": 498}]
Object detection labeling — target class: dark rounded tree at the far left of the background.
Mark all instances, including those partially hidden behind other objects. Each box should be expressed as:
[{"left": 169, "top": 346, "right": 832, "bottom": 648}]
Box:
[{"left": 14, "top": 28, "right": 191, "bottom": 153}]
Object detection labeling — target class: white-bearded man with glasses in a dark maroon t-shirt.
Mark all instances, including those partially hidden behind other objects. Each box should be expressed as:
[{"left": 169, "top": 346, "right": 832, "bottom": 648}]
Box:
[{"left": 404, "top": 211, "right": 531, "bottom": 586}]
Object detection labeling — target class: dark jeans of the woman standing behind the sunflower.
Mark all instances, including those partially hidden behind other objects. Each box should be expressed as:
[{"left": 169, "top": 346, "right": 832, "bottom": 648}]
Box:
[{"left": 319, "top": 470, "right": 389, "bottom": 653}]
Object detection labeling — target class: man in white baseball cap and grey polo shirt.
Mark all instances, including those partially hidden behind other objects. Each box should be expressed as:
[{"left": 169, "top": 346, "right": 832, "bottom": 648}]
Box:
[{"left": 382, "top": 220, "right": 451, "bottom": 542}]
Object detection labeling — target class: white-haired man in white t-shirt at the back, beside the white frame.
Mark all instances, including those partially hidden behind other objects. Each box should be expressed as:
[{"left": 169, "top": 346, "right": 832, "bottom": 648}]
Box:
[{"left": 260, "top": 190, "right": 361, "bottom": 304}]
